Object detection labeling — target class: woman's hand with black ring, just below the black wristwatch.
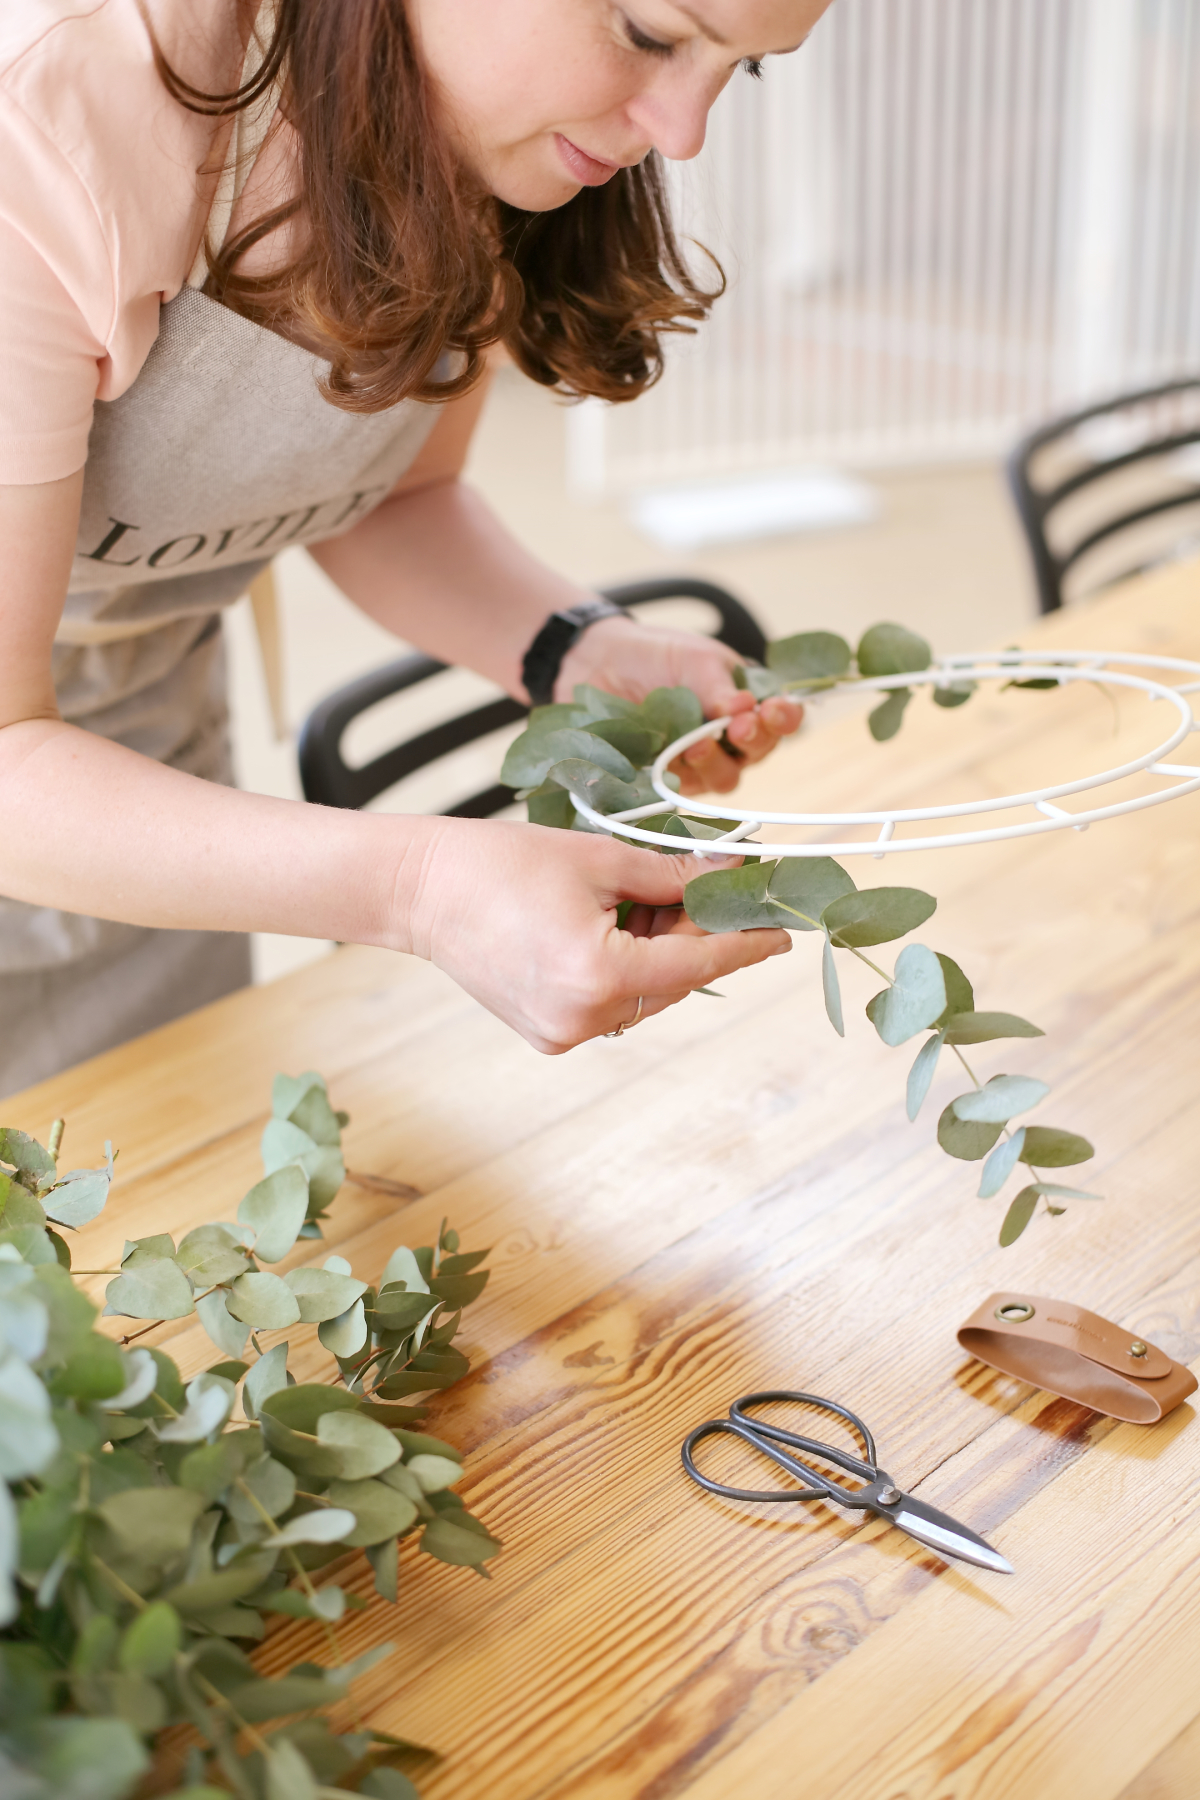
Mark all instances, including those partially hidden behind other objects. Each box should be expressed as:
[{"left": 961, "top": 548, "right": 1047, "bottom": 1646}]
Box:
[{"left": 554, "top": 619, "right": 804, "bottom": 794}]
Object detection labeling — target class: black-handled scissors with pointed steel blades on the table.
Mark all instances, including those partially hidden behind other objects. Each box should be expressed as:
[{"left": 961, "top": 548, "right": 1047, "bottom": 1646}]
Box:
[{"left": 682, "top": 1388, "right": 1015, "bottom": 1575}]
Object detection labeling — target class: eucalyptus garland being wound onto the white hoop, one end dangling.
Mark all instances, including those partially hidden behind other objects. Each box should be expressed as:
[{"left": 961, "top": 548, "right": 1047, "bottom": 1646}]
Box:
[{"left": 502, "top": 625, "right": 1099, "bottom": 1246}]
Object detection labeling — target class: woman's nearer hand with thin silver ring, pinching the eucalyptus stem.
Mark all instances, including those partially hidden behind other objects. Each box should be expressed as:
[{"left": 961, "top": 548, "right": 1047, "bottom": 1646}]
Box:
[{"left": 396, "top": 819, "right": 792, "bottom": 1057}]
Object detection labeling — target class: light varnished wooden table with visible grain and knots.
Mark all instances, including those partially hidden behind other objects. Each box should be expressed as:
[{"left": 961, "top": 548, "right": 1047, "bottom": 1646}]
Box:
[{"left": 4, "top": 565, "right": 1200, "bottom": 1800}]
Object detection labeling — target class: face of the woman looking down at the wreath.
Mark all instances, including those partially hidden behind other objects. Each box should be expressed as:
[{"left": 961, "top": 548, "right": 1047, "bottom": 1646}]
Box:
[{"left": 408, "top": 0, "right": 829, "bottom": 212}]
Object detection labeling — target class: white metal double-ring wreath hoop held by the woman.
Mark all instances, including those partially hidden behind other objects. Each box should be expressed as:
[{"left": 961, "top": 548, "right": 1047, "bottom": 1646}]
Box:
[{"left": 572, "top": 650, "right": 1200, "bottom": 857}]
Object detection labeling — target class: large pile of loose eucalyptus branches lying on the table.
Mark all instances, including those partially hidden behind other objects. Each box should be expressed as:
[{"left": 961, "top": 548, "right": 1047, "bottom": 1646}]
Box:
[{"left": 0, "top": 1073, "right": 500, "bottom": 1800}]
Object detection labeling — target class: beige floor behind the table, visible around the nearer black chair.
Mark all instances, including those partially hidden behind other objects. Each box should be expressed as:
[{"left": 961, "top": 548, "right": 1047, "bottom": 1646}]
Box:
[{"left": 228, "top": 369, "right": 1034, "bottom": 979}]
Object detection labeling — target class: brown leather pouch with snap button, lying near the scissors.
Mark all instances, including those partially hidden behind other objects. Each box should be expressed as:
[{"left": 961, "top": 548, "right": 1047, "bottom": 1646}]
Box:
[{"left": 959, "top": 1292, "right": 1196, "bottom": 1426}]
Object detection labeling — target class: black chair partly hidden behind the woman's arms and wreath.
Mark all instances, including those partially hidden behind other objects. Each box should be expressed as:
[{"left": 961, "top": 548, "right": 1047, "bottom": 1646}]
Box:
[{"left": 299, "top": 574, "right": 766, "bottom": 819}]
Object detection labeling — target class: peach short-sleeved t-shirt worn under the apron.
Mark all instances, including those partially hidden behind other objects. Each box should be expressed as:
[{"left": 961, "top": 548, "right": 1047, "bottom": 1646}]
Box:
[{"left": 0, "top": 0, "right": 278, "bottom": 484}]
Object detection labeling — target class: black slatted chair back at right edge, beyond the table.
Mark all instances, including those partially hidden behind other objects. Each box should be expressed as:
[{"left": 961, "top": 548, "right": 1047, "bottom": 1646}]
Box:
[{"left": 1007, "top": 378, "right": 1200, "bottom": 612}]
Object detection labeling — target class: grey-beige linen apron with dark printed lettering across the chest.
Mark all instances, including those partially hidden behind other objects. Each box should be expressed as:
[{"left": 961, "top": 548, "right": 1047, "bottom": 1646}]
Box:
[{"left": 0, "top": 288, "right": 437, "bottom": 1094}]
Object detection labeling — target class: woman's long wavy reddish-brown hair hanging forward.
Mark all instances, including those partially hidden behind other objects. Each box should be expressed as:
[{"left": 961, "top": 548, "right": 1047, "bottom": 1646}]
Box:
[{"left": 151, "top": 0, "right": 725, "bottom": 412}]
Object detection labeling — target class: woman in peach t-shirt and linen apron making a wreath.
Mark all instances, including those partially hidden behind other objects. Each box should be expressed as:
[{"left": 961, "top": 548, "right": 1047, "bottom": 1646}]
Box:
[{"left": 0, "top": 0, "right": 824, "bottom": 1093}]
